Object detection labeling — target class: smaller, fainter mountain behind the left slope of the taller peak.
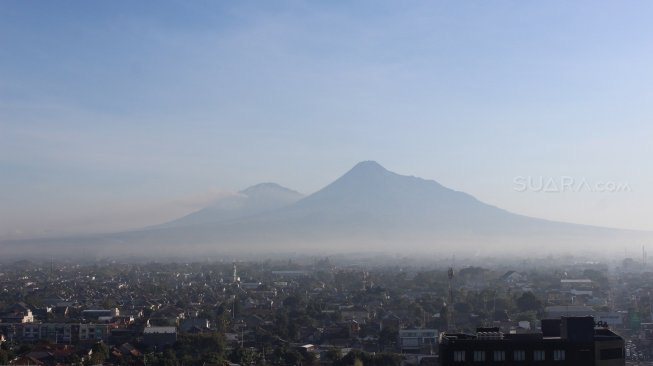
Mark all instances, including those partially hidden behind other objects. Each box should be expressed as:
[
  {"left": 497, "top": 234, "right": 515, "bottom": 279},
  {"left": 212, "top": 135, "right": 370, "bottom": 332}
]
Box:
[{"left": 157, "top": 183, "right": 304, "bottom": 228}]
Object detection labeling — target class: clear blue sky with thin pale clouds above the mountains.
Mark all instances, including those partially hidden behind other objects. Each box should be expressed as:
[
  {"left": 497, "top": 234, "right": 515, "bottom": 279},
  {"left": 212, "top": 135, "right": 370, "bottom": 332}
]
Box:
[{"left": 0, "top": 1, "right": 653, "bottom": 237}]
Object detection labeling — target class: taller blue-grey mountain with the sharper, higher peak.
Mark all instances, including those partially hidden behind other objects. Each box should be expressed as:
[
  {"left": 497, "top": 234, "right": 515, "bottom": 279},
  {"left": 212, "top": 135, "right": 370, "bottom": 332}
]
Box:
[{"left": 224, "top": 161, "right": 615, "bottom": 250}]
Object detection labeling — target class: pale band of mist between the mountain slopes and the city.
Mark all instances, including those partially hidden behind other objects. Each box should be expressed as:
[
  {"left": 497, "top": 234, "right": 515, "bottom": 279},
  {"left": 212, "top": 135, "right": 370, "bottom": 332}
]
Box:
[{"left": 0, "top": 225, "right": 640, "bottom": 259}]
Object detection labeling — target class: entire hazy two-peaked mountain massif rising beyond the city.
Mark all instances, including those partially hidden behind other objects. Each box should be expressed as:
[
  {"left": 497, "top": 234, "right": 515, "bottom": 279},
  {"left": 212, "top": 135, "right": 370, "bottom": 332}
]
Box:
[{"left": 4, "top": 161, "right": 651, "bottom": 256}]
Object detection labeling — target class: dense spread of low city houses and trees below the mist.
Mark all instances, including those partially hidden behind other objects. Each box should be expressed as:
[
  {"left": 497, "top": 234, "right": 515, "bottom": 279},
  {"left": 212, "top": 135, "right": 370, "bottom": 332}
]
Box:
[{"left": 0, "top": 257, "right": 653, "bottom": 366}]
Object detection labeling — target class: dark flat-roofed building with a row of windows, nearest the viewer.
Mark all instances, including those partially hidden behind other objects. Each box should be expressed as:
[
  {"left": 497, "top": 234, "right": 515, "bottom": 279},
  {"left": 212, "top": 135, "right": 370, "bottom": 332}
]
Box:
[{"left": 438, "top": 317, "right": 625, "bottom": 366}]
